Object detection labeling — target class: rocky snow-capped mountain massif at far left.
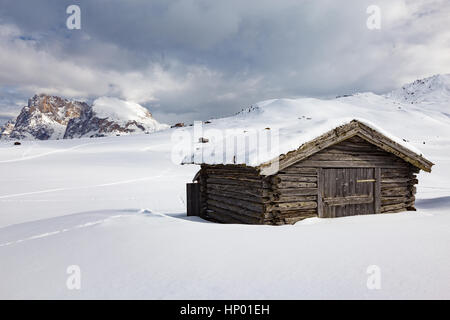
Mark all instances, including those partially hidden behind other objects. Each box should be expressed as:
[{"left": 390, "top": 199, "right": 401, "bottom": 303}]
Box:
[{"left": 0, "top": 94, "right": 169, "bottom": 140}]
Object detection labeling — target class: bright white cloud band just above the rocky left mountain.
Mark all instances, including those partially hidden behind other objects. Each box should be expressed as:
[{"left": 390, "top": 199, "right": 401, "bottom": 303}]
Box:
[{"left": 0, "top": 25, "right": 196, "bottom": 103}]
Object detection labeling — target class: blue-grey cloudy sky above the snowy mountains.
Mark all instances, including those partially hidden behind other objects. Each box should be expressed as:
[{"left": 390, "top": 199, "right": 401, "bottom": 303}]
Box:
[{"left": 0, "top": 0, "right": 450, "bottom": 123}]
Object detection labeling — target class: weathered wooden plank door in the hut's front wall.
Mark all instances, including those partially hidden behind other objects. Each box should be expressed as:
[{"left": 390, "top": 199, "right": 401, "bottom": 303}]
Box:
[{"left": 319, "top": 168, "right": 376, "bottom": 218}]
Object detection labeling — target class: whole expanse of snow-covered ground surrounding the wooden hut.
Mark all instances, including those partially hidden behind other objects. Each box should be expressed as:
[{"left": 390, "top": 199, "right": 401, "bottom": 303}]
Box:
[{"left": 0, "top": 87, "right": 450, "bottom": 299}]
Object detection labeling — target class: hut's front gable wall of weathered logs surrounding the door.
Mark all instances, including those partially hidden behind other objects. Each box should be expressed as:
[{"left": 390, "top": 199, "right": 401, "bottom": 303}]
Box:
[{"left": 272, "top": 136, "right": 418, "bottom": 223}]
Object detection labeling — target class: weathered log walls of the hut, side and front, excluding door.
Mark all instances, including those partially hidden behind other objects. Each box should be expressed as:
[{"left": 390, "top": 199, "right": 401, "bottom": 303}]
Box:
[{"left": 198, "top": 137, "right": 418, "bottom": 224}]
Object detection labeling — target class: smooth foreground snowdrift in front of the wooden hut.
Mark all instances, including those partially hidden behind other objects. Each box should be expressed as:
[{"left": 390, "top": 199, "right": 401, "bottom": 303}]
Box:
[{"left": 0, "top": 206, "right": 450, "bottom": 299}]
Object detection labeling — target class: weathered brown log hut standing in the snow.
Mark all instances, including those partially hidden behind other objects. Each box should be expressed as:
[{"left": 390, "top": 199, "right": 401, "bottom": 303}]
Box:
[{"left": 187, "top": 120, "right": 433, "bottom": 225}]
